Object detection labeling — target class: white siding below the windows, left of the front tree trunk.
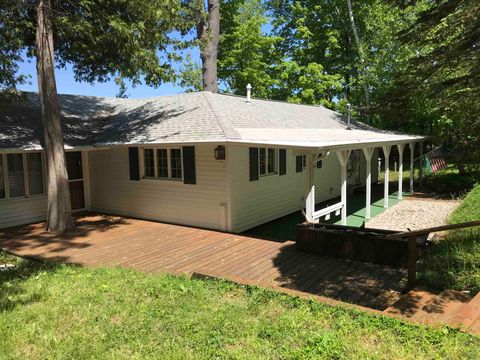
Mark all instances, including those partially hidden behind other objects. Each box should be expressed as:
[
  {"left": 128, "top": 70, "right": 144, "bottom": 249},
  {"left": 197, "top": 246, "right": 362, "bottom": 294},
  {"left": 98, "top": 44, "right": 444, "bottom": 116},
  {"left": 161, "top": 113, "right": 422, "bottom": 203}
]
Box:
[{"left": 0, "top": 195, "right": 47, "bottom": 229}]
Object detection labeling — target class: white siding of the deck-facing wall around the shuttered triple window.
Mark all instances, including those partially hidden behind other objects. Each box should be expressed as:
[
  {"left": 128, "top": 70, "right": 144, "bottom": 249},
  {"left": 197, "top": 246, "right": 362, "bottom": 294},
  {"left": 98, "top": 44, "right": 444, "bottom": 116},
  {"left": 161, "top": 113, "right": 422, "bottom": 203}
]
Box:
[{"left": 89, "top": 144, "right": 227, "bottom": 230}]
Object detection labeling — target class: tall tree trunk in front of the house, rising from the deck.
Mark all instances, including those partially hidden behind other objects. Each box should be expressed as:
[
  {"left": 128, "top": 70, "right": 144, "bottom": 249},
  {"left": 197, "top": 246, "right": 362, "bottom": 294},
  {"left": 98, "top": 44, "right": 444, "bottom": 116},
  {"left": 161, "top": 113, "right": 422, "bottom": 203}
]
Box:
[{"left": 36, "top": 0, "right": 74, "bottom": 232}]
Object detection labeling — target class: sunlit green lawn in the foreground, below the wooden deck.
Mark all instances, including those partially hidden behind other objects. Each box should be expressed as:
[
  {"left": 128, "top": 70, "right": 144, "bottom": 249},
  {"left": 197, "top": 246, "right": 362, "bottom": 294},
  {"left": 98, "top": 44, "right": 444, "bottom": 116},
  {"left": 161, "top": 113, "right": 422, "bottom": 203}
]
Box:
[{"left": 0, "top": 254, "right": 480, "bottom": 359}]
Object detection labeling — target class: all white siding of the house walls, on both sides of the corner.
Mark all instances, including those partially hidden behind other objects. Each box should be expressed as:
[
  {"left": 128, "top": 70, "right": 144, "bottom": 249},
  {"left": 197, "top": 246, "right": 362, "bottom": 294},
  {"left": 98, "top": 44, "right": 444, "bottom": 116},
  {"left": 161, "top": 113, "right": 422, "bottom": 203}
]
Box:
[{"left": 0, "top": 144, "right": 378, "bottom": 232}]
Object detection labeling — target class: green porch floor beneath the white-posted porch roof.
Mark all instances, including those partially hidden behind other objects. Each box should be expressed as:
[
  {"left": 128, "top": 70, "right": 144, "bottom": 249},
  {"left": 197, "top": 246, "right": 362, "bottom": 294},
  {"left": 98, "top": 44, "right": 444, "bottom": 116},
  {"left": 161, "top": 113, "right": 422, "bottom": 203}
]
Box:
[{"left": 244, "top": 186, "right": 409, "bottom": 241}]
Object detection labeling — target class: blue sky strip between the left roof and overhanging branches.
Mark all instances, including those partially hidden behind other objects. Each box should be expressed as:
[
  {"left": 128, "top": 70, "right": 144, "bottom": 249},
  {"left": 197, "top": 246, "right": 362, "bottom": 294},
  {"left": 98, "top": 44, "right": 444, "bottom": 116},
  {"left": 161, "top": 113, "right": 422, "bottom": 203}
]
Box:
[{"left": 18, "top": 54, "right": 194, "bottom": 98}]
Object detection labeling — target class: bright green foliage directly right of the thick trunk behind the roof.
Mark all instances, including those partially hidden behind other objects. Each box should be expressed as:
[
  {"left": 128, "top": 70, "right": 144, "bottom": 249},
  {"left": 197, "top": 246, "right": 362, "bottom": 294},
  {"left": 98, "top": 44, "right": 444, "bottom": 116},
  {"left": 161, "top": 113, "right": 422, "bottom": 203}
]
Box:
[{"left": 219, "top": 0, "right": 340, "bottom": 106}]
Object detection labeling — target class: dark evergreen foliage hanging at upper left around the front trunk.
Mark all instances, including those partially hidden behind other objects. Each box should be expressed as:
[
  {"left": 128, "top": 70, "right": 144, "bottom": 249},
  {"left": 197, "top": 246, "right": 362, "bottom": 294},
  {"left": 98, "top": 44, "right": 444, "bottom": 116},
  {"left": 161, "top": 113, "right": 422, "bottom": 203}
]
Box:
[{"left": 0, "top": 0, "right": 180, "bottom": 92}]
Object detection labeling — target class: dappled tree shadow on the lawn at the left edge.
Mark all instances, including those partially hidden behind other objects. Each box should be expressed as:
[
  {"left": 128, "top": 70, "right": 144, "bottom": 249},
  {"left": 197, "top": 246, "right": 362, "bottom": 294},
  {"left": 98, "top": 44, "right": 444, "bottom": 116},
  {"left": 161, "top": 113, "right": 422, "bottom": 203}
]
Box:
[{"left": 0, "top": 250, "right": 68, "bottom": 312}]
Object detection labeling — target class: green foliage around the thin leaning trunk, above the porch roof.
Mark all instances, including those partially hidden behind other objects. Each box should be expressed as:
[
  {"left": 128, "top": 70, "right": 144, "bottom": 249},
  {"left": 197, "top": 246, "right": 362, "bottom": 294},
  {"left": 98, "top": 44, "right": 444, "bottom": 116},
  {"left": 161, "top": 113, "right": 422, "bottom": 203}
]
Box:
[{"left": 270, "top": 0, "right": 424, "bottom": 121}]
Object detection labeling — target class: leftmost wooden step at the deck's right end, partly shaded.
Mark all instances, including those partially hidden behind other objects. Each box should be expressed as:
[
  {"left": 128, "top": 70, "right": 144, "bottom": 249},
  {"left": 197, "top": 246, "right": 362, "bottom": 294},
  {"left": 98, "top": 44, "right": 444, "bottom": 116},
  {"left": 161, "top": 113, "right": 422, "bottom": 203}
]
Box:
[{"left": 384, "top": 286, "right": 440, "bottom": 318}]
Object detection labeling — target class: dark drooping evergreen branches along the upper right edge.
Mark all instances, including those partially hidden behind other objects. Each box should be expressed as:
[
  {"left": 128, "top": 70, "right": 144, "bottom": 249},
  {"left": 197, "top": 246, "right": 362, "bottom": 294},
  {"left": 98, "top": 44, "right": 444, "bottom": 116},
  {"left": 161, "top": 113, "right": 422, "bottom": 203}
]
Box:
[{"left": 398, "top": 0, "right": 480, "bottom": 177}]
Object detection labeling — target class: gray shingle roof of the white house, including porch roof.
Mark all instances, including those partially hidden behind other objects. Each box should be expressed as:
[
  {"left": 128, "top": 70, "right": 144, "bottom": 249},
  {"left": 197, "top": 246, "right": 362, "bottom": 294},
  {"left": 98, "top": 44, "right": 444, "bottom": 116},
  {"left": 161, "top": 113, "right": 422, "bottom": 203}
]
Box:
[{"left": 0, "top": 92, "right": 422, "bottom": 149}]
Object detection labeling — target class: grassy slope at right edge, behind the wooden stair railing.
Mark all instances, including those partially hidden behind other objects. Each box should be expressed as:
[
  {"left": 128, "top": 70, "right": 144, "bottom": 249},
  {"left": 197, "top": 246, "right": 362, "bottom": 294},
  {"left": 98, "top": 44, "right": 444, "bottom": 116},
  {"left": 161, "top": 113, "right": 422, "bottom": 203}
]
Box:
[{"left": 420, "top": 184, "right": 480, "bottom": 293}]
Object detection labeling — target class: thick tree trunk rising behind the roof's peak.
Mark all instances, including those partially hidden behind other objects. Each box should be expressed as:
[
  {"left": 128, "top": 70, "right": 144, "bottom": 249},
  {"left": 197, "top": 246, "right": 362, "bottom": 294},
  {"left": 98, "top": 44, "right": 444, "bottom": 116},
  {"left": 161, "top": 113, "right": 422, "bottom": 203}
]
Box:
[{"left": 197, "top": 0, "right": 220, "bottom": 93}]
